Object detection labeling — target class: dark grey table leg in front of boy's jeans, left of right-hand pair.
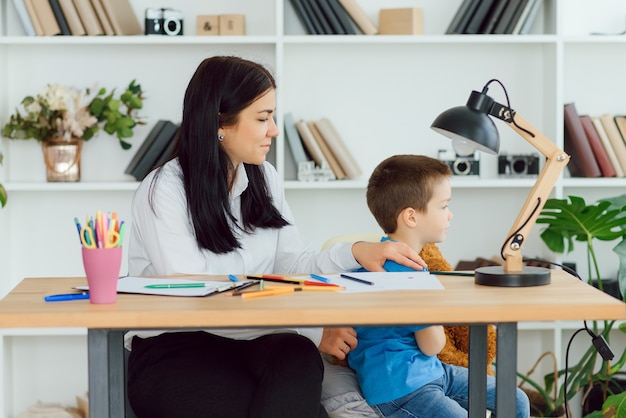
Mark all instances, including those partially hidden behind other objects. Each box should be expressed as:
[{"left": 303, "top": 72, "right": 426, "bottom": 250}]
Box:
[{"left": 468, "top": 324, "right": 486, "bottom": 418}]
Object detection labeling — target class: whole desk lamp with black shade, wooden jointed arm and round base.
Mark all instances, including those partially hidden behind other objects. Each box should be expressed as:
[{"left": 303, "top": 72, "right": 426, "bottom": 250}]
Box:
[{"left": 431, "top": 79, "right": 569, "bottom": 287}]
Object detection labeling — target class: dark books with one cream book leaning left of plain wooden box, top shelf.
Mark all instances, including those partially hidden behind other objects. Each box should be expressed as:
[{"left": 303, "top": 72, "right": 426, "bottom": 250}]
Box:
[{"left": 290, "top": 0, "right": 378, "bottom": 35}]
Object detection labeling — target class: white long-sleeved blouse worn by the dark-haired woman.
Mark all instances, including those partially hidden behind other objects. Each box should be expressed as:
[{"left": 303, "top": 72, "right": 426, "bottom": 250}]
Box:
[{"left": 126, "top": 159, "right": 360, "bottom": 348}]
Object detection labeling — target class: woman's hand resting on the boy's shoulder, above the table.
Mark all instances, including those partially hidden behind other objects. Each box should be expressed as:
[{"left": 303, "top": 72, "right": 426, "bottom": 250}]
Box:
[{"left": 352, "top": 241, "right": 428, "bottom": 271}]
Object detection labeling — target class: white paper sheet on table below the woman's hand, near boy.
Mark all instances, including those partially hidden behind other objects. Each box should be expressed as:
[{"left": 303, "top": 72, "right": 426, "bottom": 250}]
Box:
[{"left": 324, "top": 271, "right": 443, "bottom": 293}]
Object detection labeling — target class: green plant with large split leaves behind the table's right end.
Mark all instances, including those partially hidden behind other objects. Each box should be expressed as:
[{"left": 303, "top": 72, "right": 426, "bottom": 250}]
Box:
[{"left": 520, "top": 194, "right": 626, "bottom": 416}]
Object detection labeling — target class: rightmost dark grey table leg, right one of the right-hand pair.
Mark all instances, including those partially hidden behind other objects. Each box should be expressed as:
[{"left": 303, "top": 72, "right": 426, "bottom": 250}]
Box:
[{"left": 496, "top": 322, "right": 517, "bottom": 417}]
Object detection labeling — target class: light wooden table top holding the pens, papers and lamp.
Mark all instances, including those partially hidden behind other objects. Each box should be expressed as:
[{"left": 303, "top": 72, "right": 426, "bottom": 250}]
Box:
[{"left": 0, "top": 270, "right": 626, "bottom": 329}]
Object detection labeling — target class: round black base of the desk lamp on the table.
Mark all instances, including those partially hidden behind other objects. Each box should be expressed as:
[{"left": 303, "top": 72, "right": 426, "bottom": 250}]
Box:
[{"left": 474, "top": 266, "right": 550, "bottom": 287}]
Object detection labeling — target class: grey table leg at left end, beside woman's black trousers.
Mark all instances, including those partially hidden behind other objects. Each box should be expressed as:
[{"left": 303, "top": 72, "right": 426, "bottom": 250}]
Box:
[{"left": 87, "top": 329, "right": 125, "bottom": 418}]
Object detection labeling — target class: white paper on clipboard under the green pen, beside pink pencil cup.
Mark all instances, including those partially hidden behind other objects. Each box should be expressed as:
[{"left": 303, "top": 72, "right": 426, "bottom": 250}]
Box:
[{"left": 77, "top": 276, "right": 247, "bottom": 296}]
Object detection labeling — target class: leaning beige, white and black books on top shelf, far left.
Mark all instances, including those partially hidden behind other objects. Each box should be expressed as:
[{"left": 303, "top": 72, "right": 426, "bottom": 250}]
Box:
[{"left": 13, "top": 0, "right": 143, "bottom": 36}]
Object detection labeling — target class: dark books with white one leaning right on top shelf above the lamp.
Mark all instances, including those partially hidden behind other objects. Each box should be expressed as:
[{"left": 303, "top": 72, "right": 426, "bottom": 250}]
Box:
[{"left": 446, "top": 0, "right": 542, "bottom": 35}]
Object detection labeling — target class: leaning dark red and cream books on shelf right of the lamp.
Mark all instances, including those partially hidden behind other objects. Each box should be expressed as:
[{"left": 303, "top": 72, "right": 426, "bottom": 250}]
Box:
[{"left": 563, "top": 103, "right": 626, "bottom": 177}]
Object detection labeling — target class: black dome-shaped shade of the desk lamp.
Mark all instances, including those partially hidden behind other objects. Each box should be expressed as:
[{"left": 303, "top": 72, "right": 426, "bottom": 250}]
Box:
[{"left": 430, "top": 106, "right": 500, "bottom": 154}]
